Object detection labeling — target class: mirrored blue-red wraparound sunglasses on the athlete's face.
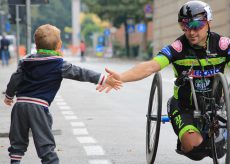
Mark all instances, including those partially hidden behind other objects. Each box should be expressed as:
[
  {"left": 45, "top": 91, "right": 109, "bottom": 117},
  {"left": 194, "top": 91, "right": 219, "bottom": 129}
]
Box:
[{"left": 180, "top": 19, "right": 207, "bottom": 31}]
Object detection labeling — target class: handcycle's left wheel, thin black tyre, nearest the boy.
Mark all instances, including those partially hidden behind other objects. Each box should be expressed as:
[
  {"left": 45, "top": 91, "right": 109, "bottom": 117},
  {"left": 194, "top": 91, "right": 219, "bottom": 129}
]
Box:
[{"left": 146, "top": 73, "right": 162, "bottom": 164}]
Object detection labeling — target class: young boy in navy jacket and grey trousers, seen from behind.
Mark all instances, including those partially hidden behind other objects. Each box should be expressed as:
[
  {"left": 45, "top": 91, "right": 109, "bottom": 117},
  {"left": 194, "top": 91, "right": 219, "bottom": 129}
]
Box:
[{"left": 4, "top": 24, "right": 121, "bottom": 164}]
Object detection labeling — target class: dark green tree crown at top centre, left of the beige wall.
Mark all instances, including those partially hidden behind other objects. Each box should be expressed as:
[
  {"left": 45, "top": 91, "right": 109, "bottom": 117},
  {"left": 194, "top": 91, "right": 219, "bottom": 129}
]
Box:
[{"left": 82, "top": 0, "right": 150, "bottom": 27}]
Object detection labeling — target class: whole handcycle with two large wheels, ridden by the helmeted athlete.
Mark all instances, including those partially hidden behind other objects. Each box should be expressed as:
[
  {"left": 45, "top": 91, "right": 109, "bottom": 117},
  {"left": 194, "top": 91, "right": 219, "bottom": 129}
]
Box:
[{"left": 146, "top": 72, "right": 230, "bottom": 164}]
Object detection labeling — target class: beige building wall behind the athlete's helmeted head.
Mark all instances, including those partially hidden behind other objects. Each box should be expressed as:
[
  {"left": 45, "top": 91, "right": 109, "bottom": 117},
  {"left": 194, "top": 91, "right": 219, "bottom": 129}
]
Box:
[{"left": 153, "top": 0, "right": 230, "bottom": 54}]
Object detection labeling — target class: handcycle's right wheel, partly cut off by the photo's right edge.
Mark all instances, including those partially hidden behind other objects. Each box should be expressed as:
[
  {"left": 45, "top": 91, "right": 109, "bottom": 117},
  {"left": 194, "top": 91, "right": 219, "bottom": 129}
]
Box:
[{"left": 211, "top": 73, "right": 230, "bottom": 164}]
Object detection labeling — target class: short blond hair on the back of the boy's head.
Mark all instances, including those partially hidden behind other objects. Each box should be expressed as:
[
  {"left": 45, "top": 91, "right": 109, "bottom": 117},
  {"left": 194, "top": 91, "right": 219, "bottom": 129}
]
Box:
[{"left": 34, "top": 24, "right": 61, "bottom": 50}]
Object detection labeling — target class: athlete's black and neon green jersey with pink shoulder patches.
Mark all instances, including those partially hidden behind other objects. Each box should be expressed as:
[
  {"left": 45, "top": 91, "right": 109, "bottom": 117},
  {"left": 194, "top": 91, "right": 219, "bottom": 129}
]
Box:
[{"left": 153, "top": 32, "right": 230, "bottom": 108}]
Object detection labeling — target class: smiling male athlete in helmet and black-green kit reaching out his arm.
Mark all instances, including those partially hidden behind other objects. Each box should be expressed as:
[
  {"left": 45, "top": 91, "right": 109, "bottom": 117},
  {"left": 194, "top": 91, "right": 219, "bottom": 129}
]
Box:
[{"left": 97, "top": 1, "right": 230, "bottom": 160}]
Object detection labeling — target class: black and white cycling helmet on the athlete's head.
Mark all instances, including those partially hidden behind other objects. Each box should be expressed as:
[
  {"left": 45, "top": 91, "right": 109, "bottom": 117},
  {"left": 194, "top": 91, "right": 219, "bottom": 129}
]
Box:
[{"left": 178, "top": 1, "right": 213, "bottom": 22}]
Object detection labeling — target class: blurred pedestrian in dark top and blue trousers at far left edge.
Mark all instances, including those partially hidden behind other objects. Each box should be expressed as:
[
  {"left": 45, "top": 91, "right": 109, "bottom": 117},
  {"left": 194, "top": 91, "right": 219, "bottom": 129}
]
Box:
[{"left": 0, "top": 33, "right": 10, "bottom": 66}]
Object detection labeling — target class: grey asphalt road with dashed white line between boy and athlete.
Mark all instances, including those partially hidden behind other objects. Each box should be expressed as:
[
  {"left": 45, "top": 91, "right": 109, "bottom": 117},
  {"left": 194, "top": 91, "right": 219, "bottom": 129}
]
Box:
[{"left": 0, "top": 55, "right": 226, "bottom": 164}]
